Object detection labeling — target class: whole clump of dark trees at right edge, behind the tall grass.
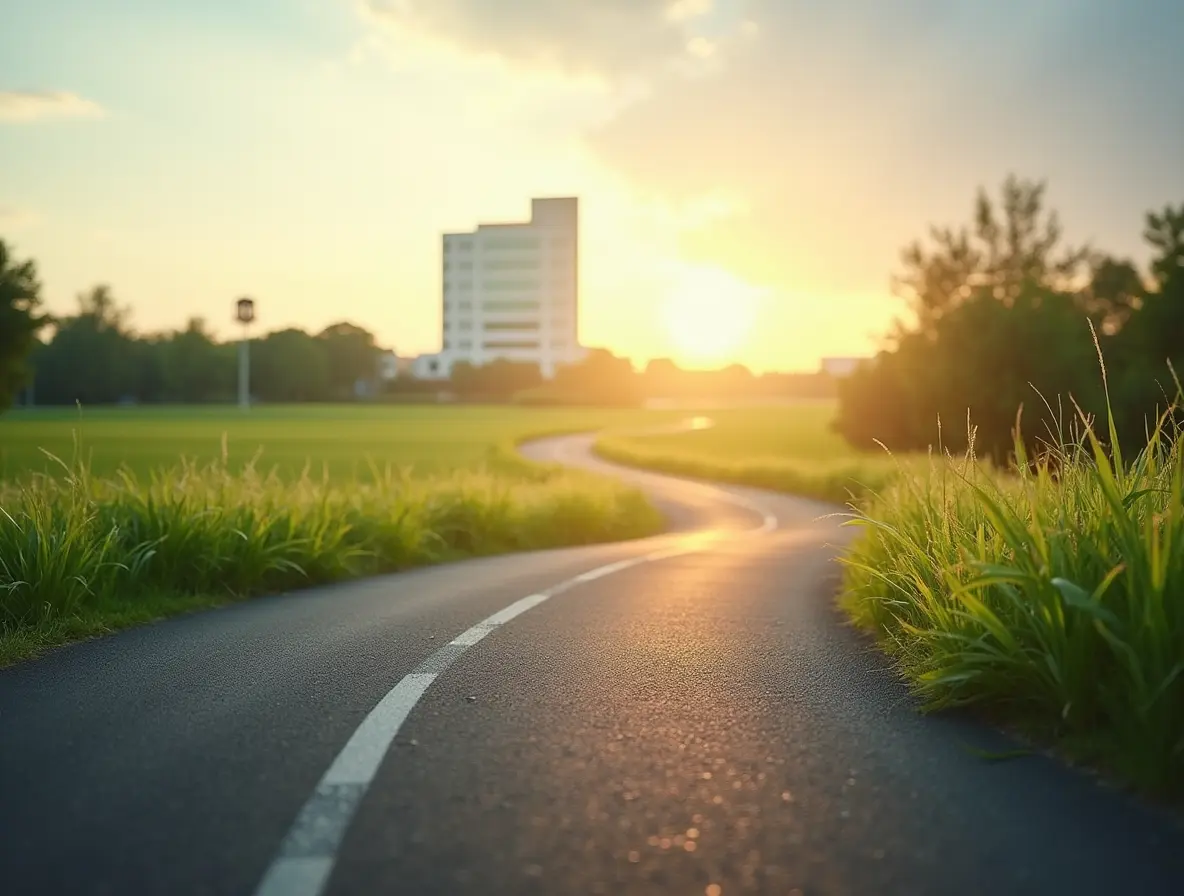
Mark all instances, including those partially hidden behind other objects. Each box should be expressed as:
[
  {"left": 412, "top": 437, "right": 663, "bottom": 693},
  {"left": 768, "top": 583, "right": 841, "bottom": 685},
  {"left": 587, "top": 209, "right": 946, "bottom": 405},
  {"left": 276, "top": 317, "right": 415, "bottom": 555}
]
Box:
[{"left": 835, "top": 175, "right": 1184, "bottom": 462}]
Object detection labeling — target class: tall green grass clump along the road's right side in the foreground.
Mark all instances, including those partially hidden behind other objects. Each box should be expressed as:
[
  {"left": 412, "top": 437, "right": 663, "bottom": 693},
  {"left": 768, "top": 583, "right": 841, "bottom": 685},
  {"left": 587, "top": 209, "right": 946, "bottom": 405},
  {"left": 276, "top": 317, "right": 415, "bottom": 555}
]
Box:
[{"left": 843, "top": 390, "right": 1184, "bottom": 798}]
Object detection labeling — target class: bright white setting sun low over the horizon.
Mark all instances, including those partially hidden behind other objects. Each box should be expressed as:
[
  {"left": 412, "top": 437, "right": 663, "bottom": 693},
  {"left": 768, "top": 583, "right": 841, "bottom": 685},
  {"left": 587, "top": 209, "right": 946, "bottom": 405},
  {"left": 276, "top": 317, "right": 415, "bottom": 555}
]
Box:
[{"left": 663, "top": 267, "right": 757, "bottom": 363}]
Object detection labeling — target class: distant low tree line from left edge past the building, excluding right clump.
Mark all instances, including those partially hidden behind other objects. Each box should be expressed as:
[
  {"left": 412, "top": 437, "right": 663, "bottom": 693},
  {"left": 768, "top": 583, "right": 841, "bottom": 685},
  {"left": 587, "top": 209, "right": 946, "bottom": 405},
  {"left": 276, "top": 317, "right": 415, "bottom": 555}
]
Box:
[{"left": 0, "top": 248, "right": 835, "bottom": 411}]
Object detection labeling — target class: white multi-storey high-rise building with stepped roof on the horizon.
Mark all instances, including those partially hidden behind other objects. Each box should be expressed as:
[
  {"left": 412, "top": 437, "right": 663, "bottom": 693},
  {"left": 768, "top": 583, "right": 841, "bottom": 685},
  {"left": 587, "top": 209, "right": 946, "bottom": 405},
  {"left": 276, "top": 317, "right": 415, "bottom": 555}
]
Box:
[{"left": 414, "top": 198, "right": 584, "bottom": 379}]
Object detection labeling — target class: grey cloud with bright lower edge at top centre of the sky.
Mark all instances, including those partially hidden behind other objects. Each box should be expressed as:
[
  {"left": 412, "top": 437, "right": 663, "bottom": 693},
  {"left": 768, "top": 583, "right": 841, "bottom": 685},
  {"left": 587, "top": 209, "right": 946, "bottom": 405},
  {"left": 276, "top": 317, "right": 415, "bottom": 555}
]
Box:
[{"left": 359, "top": 0, "right": 714, "bottom": 80}]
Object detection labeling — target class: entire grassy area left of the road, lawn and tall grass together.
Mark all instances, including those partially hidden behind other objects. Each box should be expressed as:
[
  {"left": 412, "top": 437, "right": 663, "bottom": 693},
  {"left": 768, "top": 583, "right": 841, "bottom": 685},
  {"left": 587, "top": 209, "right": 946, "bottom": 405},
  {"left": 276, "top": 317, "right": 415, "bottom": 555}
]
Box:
[{"left": 0, "top": 406, "right": 680, "bottom": 664}]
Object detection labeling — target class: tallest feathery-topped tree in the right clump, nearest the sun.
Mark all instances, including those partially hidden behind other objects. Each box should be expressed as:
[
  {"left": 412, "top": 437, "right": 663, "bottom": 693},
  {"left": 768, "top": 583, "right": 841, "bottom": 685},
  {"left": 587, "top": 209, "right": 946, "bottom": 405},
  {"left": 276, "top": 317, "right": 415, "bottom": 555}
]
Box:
[{"left": 835, "top": 176, "right": 1117, "bottom": 463}]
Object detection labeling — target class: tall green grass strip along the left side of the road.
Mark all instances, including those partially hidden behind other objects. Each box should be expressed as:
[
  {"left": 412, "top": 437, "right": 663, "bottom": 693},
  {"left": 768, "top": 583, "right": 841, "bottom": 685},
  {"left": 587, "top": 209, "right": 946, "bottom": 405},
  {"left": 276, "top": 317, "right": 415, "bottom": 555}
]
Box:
[{"left": 0, "top": 447, "right": 662, "bottom": 663}]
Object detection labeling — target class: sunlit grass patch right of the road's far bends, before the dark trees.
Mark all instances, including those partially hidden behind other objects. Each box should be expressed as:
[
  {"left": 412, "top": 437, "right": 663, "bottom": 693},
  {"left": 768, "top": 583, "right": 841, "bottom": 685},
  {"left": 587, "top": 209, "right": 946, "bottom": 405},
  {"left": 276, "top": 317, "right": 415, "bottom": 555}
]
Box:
[{"left": 597, "top": 401, "right": 899, "bottom": 503}]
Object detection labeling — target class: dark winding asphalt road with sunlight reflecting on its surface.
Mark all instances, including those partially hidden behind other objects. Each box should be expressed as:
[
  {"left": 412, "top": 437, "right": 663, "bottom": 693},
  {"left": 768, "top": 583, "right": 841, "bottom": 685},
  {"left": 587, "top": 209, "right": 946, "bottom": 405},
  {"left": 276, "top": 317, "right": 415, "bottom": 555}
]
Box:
[{"left": 0, "top": 430, "right": 1184, "bottom": 896}]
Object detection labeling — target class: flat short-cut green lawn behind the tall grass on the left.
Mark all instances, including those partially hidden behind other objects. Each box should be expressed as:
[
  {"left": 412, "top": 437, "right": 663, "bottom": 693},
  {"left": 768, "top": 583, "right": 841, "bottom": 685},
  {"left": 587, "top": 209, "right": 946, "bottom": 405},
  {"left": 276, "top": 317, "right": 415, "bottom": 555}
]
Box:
[{"left": 0, "top": 405, "right": 686, "bottom": 479}]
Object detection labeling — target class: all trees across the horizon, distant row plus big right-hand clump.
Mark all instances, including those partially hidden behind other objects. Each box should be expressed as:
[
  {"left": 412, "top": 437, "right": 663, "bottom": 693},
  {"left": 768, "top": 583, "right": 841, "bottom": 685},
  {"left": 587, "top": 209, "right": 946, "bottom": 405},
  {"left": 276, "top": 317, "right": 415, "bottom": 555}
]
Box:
[{"left": 0, "top": 175, "right": 1184, "bottom": 433}]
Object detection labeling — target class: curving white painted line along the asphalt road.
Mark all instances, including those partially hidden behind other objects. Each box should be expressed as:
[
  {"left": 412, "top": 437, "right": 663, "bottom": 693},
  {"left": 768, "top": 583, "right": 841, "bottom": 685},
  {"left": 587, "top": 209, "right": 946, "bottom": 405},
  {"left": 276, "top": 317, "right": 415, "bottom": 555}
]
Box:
[{"left": 253, "top": 492, "right": 777, "bottom": 896}]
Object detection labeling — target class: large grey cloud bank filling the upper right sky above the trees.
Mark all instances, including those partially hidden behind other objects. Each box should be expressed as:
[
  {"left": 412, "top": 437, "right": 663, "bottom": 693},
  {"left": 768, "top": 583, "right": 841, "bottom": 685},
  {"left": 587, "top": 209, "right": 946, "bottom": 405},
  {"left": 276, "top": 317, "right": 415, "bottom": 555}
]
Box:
[{"left": 588, "top": 0, "right": 1184, "bottom": 295}]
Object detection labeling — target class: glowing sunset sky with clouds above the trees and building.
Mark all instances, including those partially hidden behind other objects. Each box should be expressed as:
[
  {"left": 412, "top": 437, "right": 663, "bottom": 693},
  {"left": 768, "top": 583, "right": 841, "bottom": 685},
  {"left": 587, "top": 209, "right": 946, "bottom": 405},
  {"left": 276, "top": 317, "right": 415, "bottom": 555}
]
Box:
[{"left": 0, "top": 0, "right": 1184, "bottom": 370}]
